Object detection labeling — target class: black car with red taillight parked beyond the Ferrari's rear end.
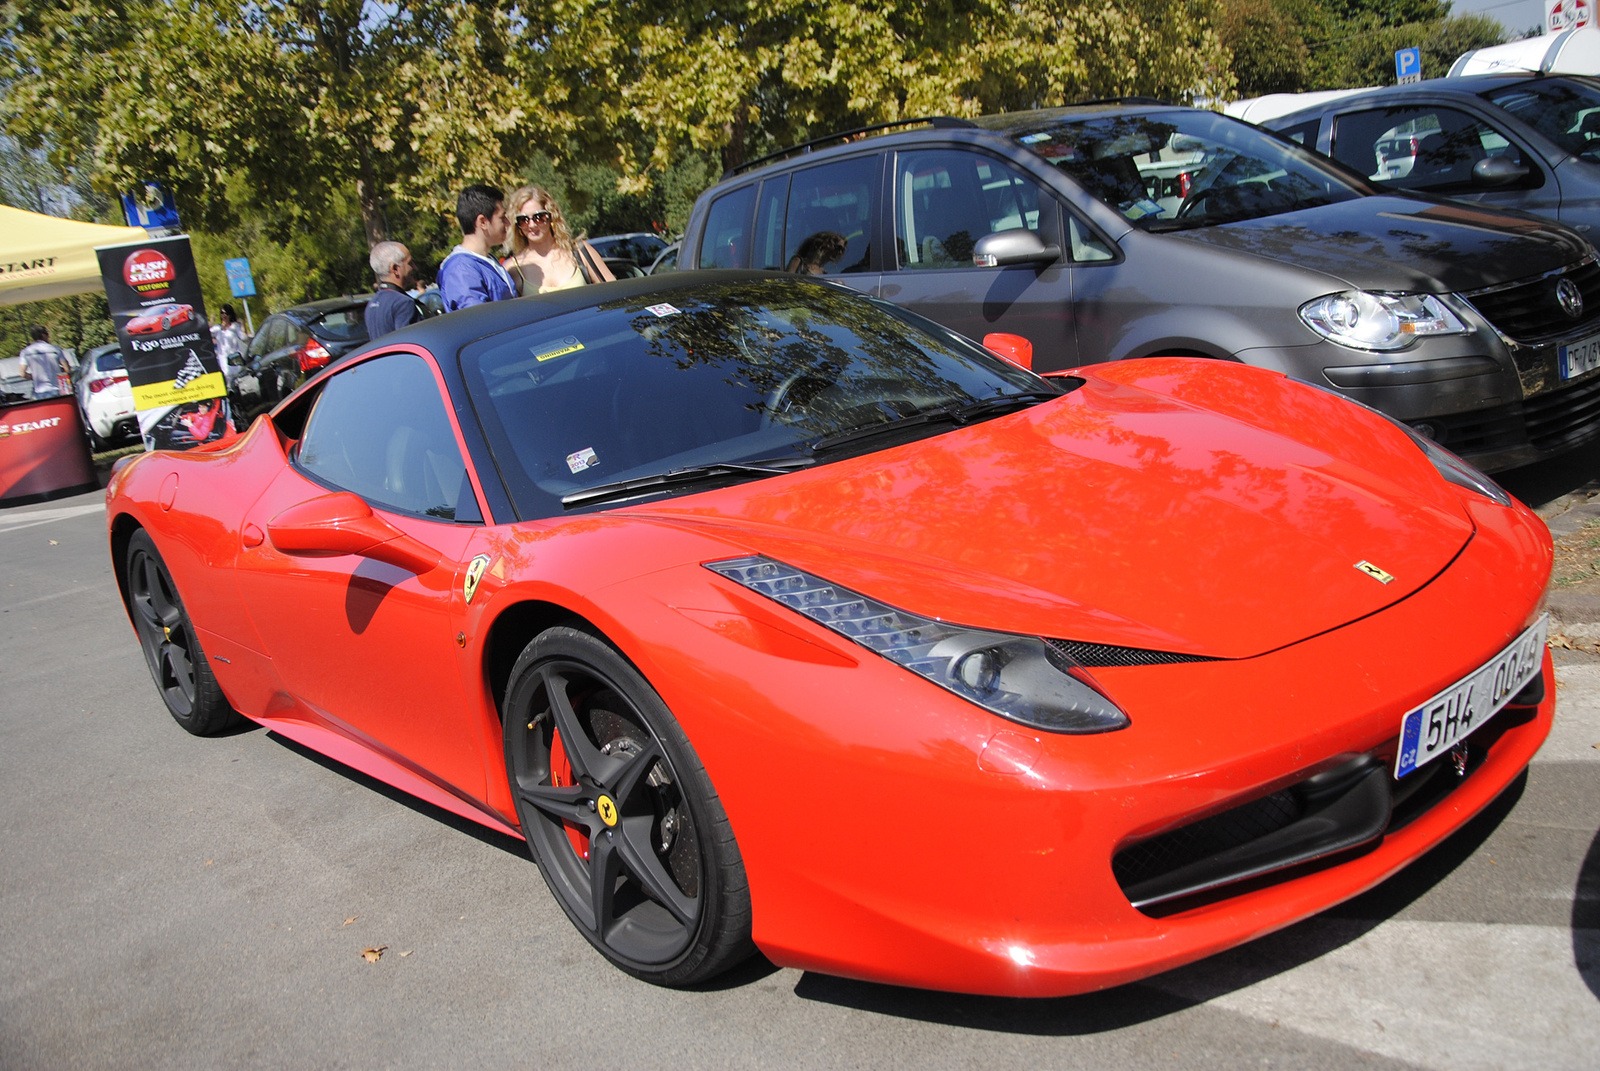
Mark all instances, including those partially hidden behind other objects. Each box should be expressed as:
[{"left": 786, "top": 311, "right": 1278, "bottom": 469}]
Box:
[{"left": 227, "top": 295, "right": 371, "bottom": 429}]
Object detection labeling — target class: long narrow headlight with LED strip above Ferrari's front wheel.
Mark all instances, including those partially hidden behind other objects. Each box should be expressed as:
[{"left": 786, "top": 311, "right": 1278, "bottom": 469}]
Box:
[{"left": 706, "top": 557, "right": 1130, "bottom": 733}]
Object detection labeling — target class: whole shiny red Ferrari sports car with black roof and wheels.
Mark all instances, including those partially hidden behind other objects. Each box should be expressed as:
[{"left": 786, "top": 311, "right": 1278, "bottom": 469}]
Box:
[{"left": 107, "top": 272, "right": 1555, "bottom": 996}]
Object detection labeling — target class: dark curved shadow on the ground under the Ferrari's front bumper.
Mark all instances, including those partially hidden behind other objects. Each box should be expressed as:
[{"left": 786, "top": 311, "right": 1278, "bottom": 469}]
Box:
[{"left": 795, "top": 772, "right": 1536, "bottom": 1036}]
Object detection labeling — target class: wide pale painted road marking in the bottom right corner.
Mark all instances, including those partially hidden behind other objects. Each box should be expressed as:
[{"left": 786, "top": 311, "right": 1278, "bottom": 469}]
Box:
[{"left": 1144, "top": 919, "right": 1600, "bottom": 1071}]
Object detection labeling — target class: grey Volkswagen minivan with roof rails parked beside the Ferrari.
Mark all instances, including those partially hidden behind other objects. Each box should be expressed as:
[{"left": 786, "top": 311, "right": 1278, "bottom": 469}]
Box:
[{"left": 682, "top": 101, "right": 1600, "bottom": 469}]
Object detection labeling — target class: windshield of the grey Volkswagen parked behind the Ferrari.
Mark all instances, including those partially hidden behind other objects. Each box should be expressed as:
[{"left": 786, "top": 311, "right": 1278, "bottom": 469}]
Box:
[{"left": 1000, "top": 109, "right": 1366, "bottom": 231}]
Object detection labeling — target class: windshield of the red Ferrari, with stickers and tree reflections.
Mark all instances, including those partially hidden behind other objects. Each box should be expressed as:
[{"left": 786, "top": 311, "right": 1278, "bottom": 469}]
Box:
[{"left": 461, "top": 279, "right": 1058, "bottom": 519}]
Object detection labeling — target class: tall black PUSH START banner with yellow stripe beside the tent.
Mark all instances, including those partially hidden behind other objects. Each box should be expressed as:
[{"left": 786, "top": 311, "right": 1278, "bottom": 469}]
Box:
[{"left": 94, "top": 235, "right": 229, "bottom": 450}]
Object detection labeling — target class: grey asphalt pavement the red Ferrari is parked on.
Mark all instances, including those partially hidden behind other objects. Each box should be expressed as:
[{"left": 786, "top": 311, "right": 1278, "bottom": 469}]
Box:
[{"left": 0, "top": 464, "right": 1600, "bottom": 1071}]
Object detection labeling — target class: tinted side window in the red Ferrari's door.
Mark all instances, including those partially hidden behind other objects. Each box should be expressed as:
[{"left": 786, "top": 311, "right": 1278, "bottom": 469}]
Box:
[{"left": 296, "top": 354, "right": 478, "bottom": 520}]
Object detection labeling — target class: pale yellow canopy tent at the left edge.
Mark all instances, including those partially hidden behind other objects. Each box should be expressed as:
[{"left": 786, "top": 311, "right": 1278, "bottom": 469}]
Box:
[{"left": 0, "top": 205, "right": 147, "bottom": 304}]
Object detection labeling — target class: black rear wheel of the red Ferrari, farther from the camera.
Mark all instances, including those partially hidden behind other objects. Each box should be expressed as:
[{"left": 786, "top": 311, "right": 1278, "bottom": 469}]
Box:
[{"left": 126, "top": 528, "right": 246, "bottom": 736}]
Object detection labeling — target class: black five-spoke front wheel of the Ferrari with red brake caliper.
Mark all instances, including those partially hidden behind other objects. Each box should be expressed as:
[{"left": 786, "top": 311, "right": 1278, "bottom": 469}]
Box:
[{"left": 506, "top": 628, "right": 754, "bottom": 986}]
